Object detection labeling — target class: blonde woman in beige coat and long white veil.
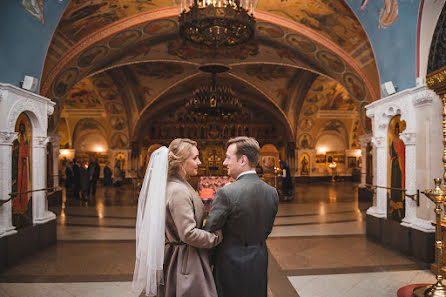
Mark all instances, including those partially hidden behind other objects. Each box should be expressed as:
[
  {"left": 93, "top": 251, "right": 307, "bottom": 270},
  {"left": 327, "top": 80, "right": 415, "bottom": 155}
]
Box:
[{"left": 132, "top": 138, "right": 222, "bottom": 297}]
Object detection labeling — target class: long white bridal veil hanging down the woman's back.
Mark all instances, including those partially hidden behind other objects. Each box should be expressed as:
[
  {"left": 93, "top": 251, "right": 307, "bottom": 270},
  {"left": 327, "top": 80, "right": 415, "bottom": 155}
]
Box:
[{"left": 132, "top": 146, "right": 168, "bottom": 296}]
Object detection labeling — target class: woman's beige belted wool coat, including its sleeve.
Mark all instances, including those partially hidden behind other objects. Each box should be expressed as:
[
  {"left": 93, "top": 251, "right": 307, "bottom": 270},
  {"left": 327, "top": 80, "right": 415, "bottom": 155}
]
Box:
[{"left": 159, "top": 176, "right": 222, "bottom": 297}]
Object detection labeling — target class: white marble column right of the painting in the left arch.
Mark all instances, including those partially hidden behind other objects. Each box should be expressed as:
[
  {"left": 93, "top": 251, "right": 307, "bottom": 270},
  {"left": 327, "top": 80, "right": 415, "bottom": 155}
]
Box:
[{"left": 32, "top": 136, "right": 56, "bottom": 224}]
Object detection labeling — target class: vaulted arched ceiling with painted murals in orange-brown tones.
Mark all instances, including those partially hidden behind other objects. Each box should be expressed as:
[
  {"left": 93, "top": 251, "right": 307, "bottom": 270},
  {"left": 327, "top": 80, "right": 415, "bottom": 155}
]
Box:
[{"left": 40, "top": 0, "right": 380, "bottom": 147}]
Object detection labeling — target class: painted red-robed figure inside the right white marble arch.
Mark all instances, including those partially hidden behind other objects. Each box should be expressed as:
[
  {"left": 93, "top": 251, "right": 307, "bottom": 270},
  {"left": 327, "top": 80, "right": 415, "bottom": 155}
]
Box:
[{"left": 389, "top": 122, "right": 406, "bottom": 221}]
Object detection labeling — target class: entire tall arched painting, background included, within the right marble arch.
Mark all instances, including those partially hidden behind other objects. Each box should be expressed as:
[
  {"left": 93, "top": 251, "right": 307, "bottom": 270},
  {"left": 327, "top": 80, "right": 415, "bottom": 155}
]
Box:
[{"left": 387, "top": 115, "right": 406, "bottom": 222}]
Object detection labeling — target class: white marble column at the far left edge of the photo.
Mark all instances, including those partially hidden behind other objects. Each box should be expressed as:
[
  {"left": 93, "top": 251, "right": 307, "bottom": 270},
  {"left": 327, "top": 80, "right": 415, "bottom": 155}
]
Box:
[{"left": 0, "top": 132, "right": 18, "bottom": 237}]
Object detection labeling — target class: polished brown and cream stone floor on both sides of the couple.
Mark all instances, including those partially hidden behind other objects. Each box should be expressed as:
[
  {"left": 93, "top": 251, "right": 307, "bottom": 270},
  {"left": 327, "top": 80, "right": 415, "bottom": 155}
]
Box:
[{"left": 0, "top": 182, "right": 434, "bottom": 297}]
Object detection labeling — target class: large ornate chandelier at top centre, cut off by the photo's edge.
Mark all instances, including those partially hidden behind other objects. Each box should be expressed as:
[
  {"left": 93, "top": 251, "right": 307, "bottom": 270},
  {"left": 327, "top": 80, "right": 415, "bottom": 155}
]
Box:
[{"left": 179, "top": 0, "right": 255, "bottom": 47}]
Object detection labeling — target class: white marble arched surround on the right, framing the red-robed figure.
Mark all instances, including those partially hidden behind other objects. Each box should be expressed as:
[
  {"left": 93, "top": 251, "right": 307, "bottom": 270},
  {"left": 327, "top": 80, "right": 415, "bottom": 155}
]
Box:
[{"left": 366, "top": 86, "right": 443, "bottom": 232}]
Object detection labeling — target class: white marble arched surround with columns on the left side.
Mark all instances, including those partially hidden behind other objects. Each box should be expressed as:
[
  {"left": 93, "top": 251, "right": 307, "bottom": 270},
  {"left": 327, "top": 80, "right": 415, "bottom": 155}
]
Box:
[{"left": 0, "top": 83, "right": 56, "bottom": 237}]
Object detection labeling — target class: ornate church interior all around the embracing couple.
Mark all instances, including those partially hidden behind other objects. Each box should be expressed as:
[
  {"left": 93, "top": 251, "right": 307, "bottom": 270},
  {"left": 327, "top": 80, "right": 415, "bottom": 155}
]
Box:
[{"left": 0, "top": 0, "right": 446, "bottom": 297}]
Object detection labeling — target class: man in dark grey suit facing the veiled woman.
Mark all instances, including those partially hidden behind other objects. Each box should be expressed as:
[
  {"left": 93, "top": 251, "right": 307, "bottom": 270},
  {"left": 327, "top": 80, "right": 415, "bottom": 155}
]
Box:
[{"left": 205, "top": 136, "right": 279, "bottom": 297}]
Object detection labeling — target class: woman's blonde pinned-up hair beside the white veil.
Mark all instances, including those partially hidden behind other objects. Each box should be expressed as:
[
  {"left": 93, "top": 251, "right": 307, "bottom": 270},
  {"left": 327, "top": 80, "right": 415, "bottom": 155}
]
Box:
[{"left": 168, "top": 138, "right": 197, "bottom": 176}]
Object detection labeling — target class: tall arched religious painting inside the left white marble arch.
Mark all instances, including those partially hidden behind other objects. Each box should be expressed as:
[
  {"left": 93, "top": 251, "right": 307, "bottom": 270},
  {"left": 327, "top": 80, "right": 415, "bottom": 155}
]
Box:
[{"left": 11, "top": 113, "right": 32, "bottom": 229}]
